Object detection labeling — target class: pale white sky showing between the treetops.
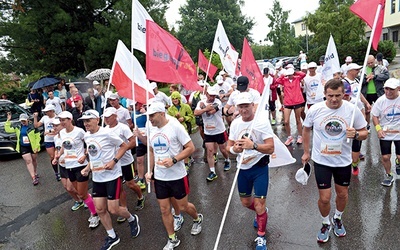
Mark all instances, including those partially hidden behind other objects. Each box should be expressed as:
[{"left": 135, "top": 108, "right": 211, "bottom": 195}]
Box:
[{"left": 166, "top": 0, "right": 319, "bottom": 44}]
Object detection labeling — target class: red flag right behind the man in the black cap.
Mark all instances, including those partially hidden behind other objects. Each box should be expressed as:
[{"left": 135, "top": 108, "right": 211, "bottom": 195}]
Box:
[{"left": 240, "top": 38, "right": 264, "bottom": 94}]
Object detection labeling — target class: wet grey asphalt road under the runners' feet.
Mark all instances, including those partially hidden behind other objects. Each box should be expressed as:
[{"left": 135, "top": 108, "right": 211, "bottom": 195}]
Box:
[{"left": 0, "top": 109, "right": 400, "bottom": 250}]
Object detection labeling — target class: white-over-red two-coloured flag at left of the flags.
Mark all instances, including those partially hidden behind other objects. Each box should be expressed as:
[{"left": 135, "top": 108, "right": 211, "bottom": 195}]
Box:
[{"left": 110, "top": 40, "right": 154, "bottom": 103}]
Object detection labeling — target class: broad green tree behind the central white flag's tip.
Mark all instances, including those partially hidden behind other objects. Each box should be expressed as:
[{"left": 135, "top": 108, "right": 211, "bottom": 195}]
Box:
[{"left": 177, "top": 0, "right": 254, "bottom": 59}]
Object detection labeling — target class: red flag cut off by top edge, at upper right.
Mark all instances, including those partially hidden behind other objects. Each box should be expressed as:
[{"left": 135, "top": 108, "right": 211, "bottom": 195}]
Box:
[{"left": 350, "top": 0, "right": 385, "bottom": 50}]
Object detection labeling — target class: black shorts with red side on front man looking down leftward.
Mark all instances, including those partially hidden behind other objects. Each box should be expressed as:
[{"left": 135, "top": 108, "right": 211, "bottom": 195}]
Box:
[{"left": 154, "top": 176, "right": 190, "bottom": 200}]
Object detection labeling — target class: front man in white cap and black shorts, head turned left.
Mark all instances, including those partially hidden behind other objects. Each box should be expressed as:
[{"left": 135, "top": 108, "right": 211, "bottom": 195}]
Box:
[{"left": 146, "top": 102, "right": 203, "bottom": 249}]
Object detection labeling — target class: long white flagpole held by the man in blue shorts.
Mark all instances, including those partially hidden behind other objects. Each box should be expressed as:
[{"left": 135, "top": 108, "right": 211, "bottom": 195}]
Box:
[{"left": 214, "top": 81, "right": 269, "bottom": 250}]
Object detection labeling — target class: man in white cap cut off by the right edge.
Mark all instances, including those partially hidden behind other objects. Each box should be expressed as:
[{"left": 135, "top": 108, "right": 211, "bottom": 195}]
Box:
[{"left": 371, "top": 78, "right": 400, "bottom": 187}]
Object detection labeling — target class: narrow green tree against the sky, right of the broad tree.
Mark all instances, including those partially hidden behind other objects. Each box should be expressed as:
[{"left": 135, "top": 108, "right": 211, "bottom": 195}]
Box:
[{"left": 266, "top": 0, "right": 297, "bottom": 56}]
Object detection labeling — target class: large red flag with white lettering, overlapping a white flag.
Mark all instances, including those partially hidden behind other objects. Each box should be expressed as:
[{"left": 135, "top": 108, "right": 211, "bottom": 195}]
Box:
[{"left": 146, "top": 20, "right": 200, "bottom": 90}]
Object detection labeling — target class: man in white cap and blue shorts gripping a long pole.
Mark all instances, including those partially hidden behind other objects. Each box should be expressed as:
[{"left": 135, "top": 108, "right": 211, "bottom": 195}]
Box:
[{"left": 226, "top": 92, "right": 274, "bottom": 250}]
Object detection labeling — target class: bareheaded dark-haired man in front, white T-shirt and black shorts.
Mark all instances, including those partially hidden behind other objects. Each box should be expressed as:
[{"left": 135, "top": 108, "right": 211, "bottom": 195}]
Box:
[{"left": 301, "top": 79, "right": 368, "bottom": 243}]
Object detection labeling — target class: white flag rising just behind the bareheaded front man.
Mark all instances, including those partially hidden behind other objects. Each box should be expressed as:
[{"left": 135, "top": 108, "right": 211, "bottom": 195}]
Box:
[{"left": 321, "top": 35, "right": 340, "bottom": 81}]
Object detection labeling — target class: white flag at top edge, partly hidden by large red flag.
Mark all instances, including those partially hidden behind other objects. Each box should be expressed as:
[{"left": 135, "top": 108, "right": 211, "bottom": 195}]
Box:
[{"left": 132, "top": 0, "right": 153, "bottom": 53}]
